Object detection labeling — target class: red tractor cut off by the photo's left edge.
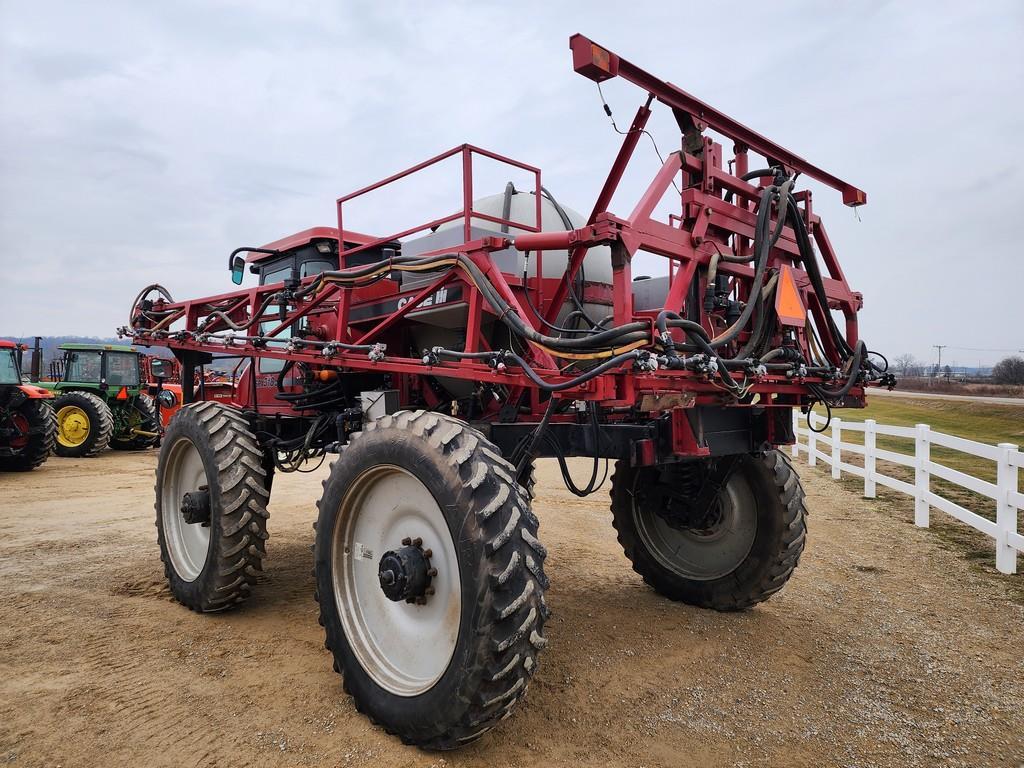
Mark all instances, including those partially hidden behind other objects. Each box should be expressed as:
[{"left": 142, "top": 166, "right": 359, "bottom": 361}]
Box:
[{"left": 0, "top": 339, "right": 56, "bottom": 472}]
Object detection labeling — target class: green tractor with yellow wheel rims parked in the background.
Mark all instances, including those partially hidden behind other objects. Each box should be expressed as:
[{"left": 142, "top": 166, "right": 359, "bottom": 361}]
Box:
[{"left": 39, "top": 344, "right": 160, "bottom": 458}]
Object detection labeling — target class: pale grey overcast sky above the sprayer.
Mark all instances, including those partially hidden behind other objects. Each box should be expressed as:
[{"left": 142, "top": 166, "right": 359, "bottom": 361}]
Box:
[{"left": 0, "top": 0, "right": 1024, "bottom": 365}]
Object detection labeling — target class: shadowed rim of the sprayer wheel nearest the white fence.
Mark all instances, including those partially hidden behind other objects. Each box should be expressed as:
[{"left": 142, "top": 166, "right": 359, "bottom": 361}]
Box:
[{"left": 631, "top": 471, "right": 758, "bottom": 582}]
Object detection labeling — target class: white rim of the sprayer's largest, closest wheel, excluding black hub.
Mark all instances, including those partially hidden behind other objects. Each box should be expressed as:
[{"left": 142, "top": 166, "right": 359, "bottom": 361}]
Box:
[{"left": 332, "top": 465, "right": 462, "bottom": 696}]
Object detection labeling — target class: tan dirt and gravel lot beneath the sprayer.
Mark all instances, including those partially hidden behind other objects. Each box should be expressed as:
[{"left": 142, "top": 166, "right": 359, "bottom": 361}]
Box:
[{"left": 0, "top": 453, "right": 1024, "bottom": 767}]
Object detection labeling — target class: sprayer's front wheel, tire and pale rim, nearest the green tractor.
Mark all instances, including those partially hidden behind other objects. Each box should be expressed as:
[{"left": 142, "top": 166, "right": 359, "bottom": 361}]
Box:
[{"left": 156, "top": 401, "right": 270, "bottom": 613}]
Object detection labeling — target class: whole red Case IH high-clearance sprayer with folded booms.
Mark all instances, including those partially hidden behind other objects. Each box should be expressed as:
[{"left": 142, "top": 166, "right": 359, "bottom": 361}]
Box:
[{"left": 122, "top": 35, "right": 894, "bottom": 749}]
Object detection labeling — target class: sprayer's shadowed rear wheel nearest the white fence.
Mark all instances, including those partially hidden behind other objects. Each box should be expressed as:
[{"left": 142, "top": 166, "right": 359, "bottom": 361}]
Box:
[{"left": 611, "top": 451, "right": 807, "bottom": 610}]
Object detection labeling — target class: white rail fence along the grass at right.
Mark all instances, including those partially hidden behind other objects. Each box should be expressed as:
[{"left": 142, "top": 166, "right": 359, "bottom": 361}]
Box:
[{"left": 792, "top": 412, "right": 1024, "bottom": 573}]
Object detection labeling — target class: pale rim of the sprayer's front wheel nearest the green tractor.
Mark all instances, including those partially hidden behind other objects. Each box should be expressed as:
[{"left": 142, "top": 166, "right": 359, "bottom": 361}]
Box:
[{"left": 160, "top": 437, "right": 210, "bottom": 582}]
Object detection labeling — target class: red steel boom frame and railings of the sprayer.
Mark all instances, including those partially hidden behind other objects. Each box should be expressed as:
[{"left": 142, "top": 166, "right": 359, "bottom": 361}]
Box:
[{"left": 125, "top": 35, "right": 866, "bottom": 442}]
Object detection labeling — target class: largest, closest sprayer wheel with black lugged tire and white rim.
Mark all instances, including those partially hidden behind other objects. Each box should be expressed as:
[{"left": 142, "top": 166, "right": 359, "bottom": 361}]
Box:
[{"left": 313, "top": 411, "right": 548, "bottom": 750}]
